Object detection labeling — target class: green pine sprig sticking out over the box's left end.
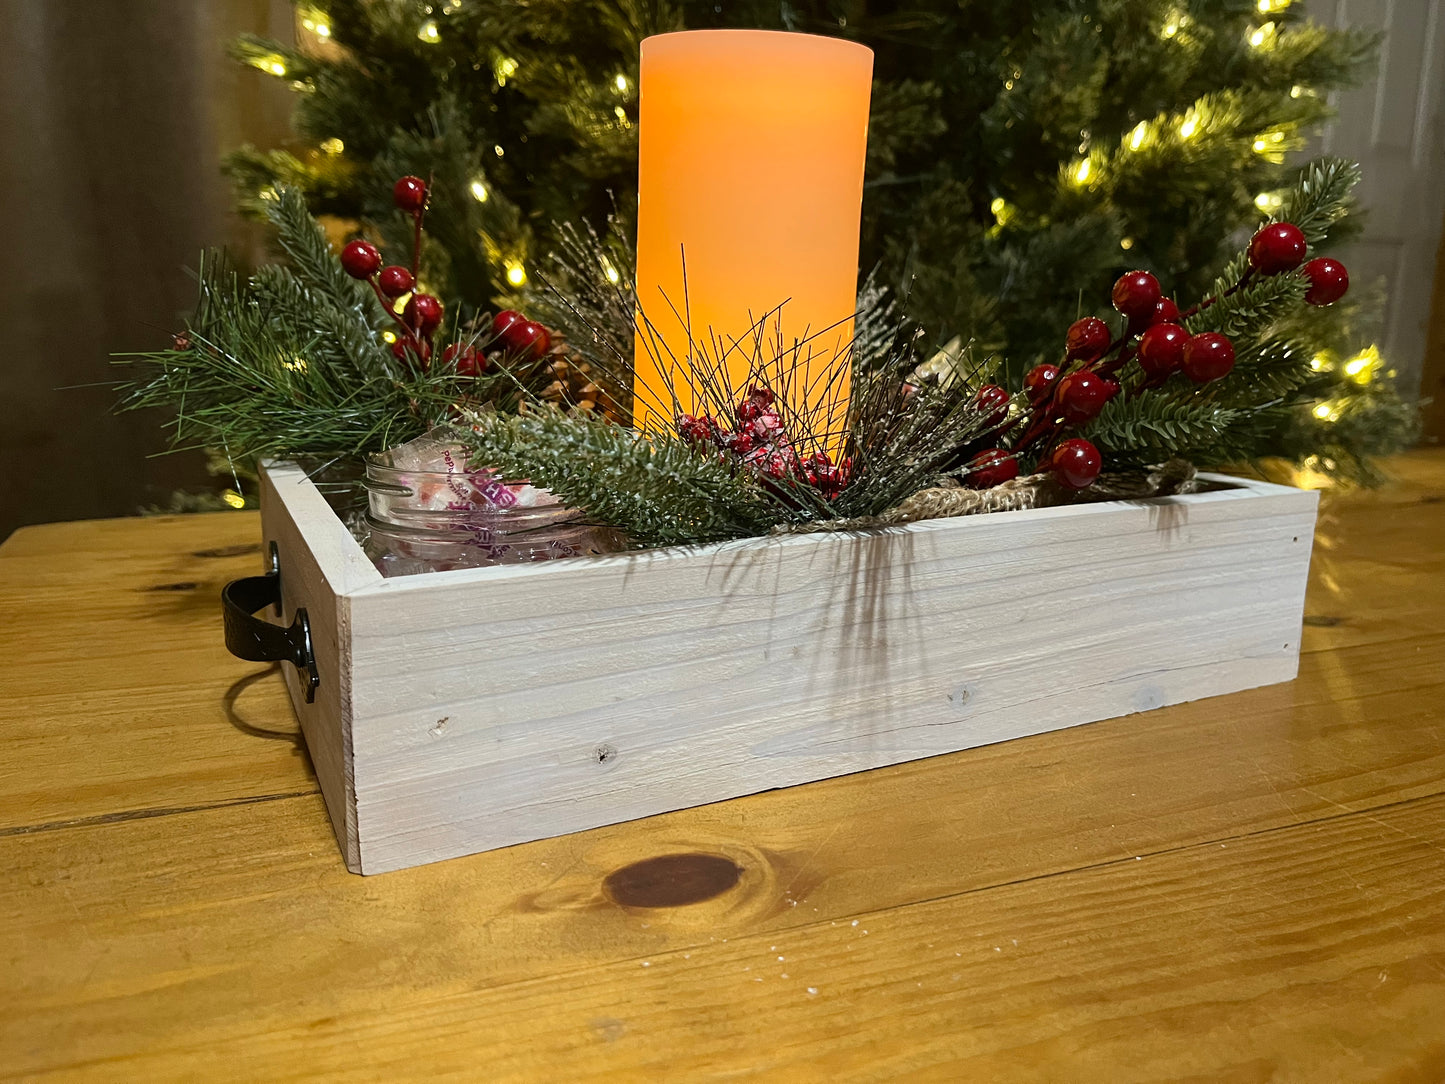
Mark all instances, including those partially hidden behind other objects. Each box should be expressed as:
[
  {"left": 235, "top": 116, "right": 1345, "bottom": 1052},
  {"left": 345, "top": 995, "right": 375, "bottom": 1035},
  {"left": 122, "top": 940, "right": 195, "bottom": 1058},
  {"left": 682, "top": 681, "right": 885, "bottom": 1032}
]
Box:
[{"left": 117, "top": 188, "right": 529, "bottom": 464}]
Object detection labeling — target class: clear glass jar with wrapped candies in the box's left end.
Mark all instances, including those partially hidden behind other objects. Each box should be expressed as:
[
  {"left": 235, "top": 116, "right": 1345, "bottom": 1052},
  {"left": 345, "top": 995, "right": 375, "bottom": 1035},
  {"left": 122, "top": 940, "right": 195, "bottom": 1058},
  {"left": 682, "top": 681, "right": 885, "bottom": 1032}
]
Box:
[{"left": 364, "top": 457, "right": 626, "bottom": 577}]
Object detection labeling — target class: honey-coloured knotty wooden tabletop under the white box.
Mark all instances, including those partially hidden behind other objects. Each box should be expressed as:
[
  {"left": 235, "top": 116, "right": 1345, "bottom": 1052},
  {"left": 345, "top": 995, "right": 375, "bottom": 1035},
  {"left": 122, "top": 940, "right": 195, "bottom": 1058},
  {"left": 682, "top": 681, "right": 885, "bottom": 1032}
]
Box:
[{"left": 0, "top": 451, "right": 1445, "bottom": 1081}]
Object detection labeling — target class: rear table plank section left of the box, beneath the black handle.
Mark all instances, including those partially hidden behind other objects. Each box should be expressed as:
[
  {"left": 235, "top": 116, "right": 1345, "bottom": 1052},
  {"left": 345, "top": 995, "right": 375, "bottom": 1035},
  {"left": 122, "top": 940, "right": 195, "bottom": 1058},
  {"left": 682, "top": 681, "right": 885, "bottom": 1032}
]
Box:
[{"left": 0, "top": 512, "right": 315, "bottom": 831}]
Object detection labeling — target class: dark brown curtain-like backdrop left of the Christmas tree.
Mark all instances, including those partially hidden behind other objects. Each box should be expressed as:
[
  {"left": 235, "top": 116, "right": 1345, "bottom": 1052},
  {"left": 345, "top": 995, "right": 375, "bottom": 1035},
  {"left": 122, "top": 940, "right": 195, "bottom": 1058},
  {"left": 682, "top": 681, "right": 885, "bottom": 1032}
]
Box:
[{"left": 0, "top": 0, "right": 290, "bottom": 538}]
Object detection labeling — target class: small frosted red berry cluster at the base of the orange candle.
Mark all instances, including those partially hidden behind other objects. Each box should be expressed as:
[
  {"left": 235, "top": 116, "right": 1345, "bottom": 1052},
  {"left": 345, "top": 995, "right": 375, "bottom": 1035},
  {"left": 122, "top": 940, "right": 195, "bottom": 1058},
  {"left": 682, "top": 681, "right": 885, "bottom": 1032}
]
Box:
[{"left": 675, "top": 386, "right": 853, "bottom": 500}]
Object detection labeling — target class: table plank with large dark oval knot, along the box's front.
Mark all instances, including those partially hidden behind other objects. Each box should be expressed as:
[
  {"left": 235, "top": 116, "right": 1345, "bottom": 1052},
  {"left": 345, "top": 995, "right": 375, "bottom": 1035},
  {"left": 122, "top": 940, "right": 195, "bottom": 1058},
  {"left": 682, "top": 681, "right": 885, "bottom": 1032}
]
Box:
[{"left": 0, "top": 627, "right": 1445, "bottom": 1068}]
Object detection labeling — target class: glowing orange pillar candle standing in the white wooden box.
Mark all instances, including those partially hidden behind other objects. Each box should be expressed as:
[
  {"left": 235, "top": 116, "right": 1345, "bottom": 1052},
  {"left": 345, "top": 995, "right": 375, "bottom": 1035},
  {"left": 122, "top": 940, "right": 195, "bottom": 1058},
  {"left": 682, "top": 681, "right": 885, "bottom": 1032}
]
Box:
[{"left": 634, "top": 30, "right": 873, "bottom": 448}]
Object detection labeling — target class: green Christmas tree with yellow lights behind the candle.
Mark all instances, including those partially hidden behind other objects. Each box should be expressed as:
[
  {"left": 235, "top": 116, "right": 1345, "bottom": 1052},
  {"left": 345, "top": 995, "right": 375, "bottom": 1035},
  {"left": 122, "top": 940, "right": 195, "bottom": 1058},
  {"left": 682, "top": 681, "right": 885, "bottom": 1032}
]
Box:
[{"left": 228, "top": 0, "right": 1415, "bottom": 477}]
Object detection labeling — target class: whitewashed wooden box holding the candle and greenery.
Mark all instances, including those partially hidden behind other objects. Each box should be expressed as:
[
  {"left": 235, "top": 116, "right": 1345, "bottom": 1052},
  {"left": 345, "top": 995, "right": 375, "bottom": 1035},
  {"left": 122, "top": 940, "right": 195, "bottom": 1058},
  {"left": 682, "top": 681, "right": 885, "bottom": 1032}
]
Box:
[{"left": 245, "top": 464, "right": 1318, "bottom": 873}]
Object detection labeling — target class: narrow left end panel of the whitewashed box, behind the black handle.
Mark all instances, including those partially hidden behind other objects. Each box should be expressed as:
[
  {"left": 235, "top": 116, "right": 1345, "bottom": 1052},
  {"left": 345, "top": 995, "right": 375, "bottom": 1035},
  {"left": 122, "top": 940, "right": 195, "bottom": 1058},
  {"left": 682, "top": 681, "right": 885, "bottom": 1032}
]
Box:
[{"left": 262, "top": 468, "right": 364, "bottom": 872}]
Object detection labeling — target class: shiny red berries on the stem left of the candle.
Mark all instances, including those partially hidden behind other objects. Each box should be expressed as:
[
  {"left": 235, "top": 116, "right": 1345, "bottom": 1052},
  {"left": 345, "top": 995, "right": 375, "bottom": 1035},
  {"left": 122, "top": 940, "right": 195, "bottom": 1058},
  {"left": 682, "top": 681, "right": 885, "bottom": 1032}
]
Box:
[{"left": 341, "top": 176, "right": 552, "bottom": 376}]
